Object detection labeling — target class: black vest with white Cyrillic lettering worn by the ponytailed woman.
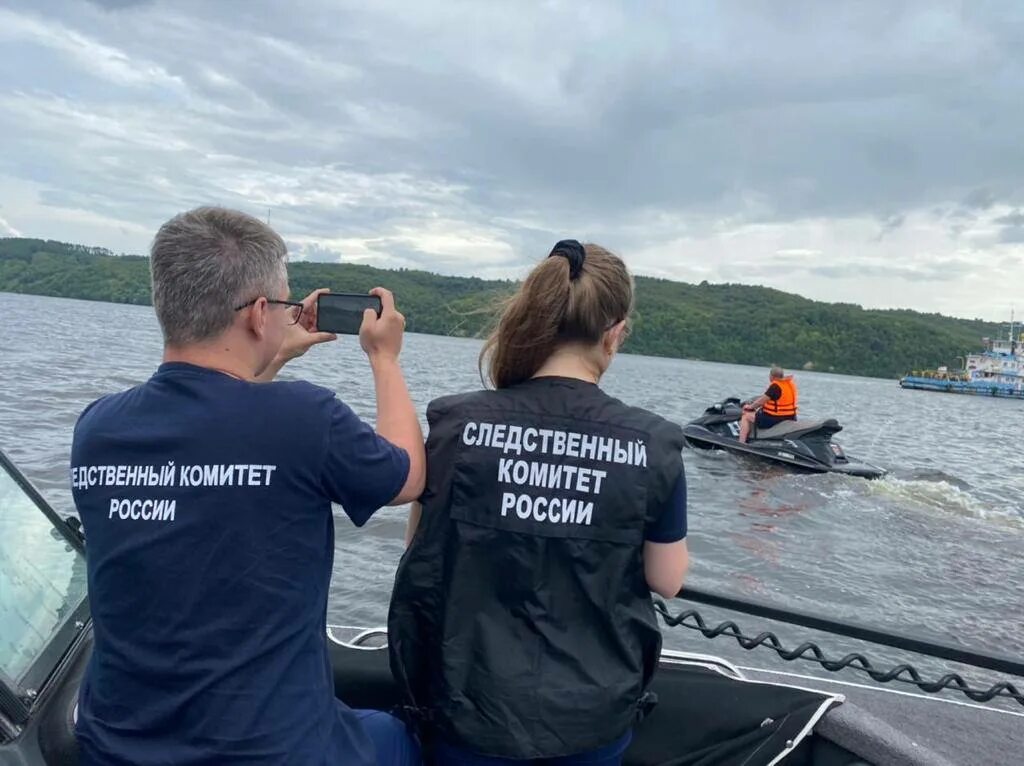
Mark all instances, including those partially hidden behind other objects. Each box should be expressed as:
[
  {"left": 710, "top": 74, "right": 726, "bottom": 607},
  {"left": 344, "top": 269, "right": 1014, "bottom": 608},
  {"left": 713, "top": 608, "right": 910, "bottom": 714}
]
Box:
[{"left": 388, "top": 378, "right": 683, "bottom": 759}]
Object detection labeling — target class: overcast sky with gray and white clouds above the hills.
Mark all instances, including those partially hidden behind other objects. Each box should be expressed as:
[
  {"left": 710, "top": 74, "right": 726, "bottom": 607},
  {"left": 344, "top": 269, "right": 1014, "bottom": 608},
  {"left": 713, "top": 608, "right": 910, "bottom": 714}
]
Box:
[{"left": 0, "top": 0, "right": 1024, "bottom": 320}]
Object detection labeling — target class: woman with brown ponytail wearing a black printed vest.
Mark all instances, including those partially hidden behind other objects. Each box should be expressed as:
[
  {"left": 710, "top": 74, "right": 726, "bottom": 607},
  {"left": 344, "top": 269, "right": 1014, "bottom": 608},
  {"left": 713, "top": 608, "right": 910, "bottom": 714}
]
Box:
[{"left": 388, "top": 240, "right": 688, "bottom": 765}]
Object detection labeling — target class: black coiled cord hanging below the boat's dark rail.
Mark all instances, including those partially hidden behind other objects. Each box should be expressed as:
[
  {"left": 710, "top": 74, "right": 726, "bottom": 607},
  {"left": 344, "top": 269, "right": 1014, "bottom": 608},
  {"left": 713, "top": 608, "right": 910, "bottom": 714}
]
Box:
[{"left": 654, "top": 599, "right": 1024, "bottom": 705}]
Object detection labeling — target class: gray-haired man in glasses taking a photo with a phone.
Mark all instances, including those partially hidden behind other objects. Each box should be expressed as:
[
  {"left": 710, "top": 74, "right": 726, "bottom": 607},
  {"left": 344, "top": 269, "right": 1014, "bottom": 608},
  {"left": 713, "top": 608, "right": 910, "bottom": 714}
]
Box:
[{"left": 72, "top": 208, "right": 425, "bottom": 766}]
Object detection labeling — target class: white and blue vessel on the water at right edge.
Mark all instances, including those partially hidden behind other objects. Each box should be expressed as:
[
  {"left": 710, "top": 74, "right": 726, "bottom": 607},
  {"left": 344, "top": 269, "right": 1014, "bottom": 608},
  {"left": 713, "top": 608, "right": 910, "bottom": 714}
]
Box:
[{"left": 899, "top": 317, "right": 1024, "bottom": 398}]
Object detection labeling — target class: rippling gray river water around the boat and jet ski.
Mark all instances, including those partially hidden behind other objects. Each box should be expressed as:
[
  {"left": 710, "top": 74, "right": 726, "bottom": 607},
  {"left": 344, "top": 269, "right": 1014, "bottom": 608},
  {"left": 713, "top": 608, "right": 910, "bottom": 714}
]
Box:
[{"left": 0, "top": 293, "right": 1024, "bottom": 700}]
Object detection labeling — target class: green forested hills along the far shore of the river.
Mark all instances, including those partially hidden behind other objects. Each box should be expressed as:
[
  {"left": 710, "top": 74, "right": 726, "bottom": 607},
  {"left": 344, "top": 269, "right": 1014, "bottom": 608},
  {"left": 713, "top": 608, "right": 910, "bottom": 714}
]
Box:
[{"left": 0, "top": 238, "right": 1004, "bottom": 377}]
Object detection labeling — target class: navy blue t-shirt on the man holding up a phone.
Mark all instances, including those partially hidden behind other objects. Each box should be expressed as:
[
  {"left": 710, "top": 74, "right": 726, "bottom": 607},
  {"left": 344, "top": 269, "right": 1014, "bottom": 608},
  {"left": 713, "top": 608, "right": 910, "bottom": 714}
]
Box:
[{"left": 72, "top": 363, "right": 409, "bottom": 766}]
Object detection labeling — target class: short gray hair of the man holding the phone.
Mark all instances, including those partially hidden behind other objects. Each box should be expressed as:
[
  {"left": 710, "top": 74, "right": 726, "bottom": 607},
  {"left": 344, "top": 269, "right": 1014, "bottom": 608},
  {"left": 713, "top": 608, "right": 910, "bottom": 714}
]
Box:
[{"left": 150, "top": 208, "right": 288, "bottom": 346}]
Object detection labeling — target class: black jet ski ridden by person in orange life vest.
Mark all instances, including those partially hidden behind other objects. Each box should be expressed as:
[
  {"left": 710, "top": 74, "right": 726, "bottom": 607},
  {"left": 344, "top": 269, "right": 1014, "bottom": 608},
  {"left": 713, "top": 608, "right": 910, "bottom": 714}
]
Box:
[{"left": 683, "top": 397, "right": 886, "bottom": 478}]
